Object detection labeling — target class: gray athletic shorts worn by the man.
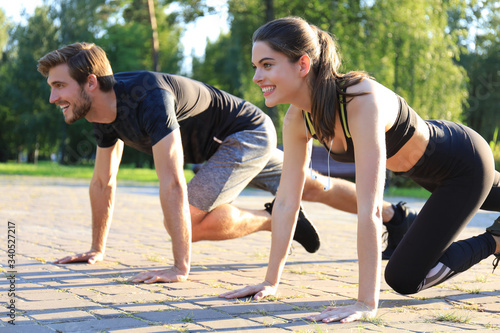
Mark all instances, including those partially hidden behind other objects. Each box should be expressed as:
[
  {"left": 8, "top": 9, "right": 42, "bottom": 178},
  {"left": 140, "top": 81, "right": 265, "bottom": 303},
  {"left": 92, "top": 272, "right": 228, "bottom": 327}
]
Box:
[{"left": 188, "top": 116, "right": 283, "bottom": 212}]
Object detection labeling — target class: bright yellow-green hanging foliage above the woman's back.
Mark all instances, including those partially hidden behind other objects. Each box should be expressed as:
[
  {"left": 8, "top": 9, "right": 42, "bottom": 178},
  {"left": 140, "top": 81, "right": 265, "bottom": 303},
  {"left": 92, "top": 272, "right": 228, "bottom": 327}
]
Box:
[{"left": 366, "top": 0, "right": 467, "bottom": 121}]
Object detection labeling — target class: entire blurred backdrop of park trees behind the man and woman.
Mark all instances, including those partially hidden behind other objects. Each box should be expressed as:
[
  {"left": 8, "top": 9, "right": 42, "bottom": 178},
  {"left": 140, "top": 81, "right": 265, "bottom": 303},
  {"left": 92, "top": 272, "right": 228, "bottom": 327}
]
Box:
[{"left": 0, "top": 0, "right": 500, "bottom": 185}]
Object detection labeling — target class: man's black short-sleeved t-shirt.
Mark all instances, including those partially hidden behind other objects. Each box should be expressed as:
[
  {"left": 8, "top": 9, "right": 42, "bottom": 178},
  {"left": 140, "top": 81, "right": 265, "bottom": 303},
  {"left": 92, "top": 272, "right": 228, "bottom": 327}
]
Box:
[{"left": 93, "top": 71, "right": 265, "bottom": 163}]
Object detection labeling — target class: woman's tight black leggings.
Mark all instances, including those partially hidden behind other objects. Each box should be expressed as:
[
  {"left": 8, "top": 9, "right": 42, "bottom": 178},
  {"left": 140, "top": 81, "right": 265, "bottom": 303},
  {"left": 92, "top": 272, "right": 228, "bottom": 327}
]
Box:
[{"left": 385, "top": 121, "right": 500, "bottom": 294}]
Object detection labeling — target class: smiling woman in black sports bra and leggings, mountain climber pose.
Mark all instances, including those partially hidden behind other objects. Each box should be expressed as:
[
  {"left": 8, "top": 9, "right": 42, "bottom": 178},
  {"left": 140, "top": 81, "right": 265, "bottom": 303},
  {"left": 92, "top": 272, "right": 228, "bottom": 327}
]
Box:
[{"left": 221, "top": 18, "right": 500, "bottom": 322}]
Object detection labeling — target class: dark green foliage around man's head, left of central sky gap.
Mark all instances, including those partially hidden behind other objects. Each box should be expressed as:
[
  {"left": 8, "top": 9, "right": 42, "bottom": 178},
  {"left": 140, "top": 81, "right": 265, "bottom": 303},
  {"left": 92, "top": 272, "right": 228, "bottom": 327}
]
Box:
[{"left": 0, "top": 0, "right": 182, "bottom": 166}]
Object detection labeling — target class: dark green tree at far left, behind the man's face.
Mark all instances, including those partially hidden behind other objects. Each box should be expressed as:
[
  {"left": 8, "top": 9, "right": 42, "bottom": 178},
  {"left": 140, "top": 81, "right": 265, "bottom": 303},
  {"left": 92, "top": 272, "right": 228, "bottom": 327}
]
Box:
[{"left": 1, "top": 6, "right": 60, "bottom": 162}]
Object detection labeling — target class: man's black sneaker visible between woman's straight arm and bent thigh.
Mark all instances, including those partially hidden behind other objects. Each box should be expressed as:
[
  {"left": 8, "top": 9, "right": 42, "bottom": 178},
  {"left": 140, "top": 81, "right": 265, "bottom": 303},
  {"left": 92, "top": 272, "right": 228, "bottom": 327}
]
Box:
[{"left": 382, "top": 201, "right": 417, "bottom": 260}]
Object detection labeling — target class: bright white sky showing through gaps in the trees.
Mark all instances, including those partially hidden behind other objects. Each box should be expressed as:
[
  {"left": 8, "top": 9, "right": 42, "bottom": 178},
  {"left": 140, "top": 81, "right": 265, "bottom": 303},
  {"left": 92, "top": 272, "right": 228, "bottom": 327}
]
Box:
[{"left": 0, "top": 0, "right": 228, "bottom": 70}]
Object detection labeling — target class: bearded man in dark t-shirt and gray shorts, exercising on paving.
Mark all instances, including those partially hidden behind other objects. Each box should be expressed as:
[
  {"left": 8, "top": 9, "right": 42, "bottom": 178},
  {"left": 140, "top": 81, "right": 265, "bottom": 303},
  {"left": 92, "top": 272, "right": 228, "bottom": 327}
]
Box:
[{"left": 38, "top": 43, "right": 415, "bottom": 283}]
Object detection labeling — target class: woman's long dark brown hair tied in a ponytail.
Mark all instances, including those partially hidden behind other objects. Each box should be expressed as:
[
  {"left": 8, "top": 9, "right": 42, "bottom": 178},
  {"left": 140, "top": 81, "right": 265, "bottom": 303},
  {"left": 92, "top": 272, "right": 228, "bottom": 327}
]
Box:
[{"left": 252, "top": 17, "right": 369, "bottom": 141}]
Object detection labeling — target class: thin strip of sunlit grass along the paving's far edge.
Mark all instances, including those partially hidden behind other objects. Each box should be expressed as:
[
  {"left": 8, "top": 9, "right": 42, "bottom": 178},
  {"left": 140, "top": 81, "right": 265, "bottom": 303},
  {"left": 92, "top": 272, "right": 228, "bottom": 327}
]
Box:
[{"left": 0, "top": 161, "right": 430, "bottom": 199}]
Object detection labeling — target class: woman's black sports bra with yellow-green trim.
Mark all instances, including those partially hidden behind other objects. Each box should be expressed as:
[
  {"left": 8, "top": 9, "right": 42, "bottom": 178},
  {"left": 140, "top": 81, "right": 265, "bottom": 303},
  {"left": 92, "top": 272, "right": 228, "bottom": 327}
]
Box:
[{"left": 302, "top": 94, "right": 417, "bottom": 163}]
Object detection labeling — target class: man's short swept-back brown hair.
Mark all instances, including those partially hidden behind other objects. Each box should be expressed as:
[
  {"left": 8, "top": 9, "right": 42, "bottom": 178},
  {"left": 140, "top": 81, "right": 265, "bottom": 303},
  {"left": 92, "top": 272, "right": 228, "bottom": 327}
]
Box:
[{"left": 37, "top": 43, "right": 116, "bottom": 91}]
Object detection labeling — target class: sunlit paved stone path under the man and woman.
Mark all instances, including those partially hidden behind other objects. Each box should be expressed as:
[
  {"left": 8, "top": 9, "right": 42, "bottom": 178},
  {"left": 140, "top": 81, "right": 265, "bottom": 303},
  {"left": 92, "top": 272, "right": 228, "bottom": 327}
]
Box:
[{"left": 0, "top": 176, "right": 500, "bottom": 332}]
